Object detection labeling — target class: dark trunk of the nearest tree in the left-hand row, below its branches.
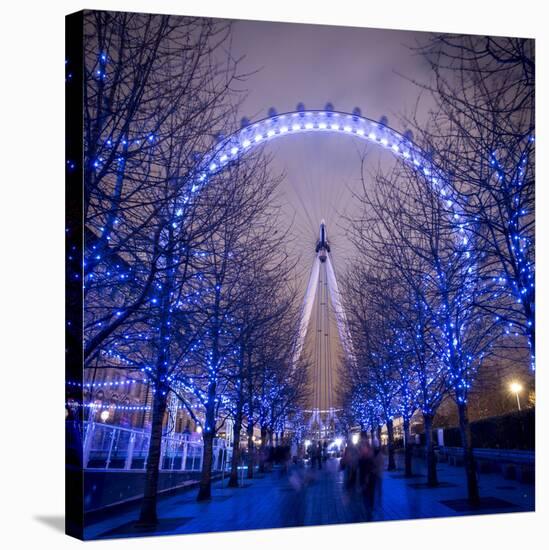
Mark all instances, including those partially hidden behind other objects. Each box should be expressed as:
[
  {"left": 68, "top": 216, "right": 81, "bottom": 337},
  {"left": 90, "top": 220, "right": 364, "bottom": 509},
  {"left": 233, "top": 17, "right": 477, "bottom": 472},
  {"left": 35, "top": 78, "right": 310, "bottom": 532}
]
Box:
[{"left": 137, "top": 389, "right": 167, "bottom": 526}]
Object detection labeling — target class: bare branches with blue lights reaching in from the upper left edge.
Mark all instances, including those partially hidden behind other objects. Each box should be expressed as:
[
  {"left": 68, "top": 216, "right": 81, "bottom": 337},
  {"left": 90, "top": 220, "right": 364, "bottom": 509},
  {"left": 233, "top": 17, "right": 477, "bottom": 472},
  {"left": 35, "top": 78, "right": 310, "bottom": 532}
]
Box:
[{"left": 84, "top": 12, "right": 242, "bottom": 362}]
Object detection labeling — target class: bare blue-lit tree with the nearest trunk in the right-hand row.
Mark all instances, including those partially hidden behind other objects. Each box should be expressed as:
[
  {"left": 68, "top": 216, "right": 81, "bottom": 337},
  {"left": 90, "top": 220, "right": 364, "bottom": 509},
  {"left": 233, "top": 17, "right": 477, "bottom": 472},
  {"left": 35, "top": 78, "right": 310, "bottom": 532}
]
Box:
[{"left": 346, "top": 156, "right": 501, "bottom": 503}]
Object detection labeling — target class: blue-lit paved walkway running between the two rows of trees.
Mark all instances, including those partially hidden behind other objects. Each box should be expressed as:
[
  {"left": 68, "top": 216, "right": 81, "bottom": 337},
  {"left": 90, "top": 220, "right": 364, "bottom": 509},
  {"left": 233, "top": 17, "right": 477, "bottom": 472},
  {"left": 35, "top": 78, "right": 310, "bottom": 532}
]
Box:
[{"left": 86, "top": 460, "right": 534, "bottom": 538}]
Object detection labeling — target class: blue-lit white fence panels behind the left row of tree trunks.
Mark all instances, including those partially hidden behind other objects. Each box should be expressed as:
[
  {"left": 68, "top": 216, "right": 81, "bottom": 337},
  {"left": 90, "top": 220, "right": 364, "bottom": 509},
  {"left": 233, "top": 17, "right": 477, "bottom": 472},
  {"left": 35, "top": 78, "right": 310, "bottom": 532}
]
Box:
[{"left": 83, "top": 422, "right": 232, "bottom": 472}]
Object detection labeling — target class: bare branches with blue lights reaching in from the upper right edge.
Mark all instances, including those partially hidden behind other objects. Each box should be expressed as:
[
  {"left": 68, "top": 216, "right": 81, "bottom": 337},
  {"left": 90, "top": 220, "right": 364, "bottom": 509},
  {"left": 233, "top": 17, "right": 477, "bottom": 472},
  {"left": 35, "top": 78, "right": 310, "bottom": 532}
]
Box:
[{"left": 413, "top": 35, "right": 535, "bottom": 367}]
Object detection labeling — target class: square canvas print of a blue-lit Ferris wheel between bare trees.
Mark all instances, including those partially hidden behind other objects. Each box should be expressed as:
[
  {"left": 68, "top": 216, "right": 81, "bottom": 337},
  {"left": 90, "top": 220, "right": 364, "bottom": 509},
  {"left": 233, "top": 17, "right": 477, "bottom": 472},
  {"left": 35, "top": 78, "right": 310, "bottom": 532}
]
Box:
[{"left": 66, "top": 12, "right": 536, "bottom": 539}]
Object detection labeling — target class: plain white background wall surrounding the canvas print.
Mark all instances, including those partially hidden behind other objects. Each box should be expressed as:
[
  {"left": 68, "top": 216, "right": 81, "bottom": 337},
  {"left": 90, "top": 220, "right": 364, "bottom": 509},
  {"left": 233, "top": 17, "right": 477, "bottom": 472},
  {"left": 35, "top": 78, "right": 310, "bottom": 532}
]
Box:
[{"left": 0, "top": 0, "right": 549, "bottom": 550}]
